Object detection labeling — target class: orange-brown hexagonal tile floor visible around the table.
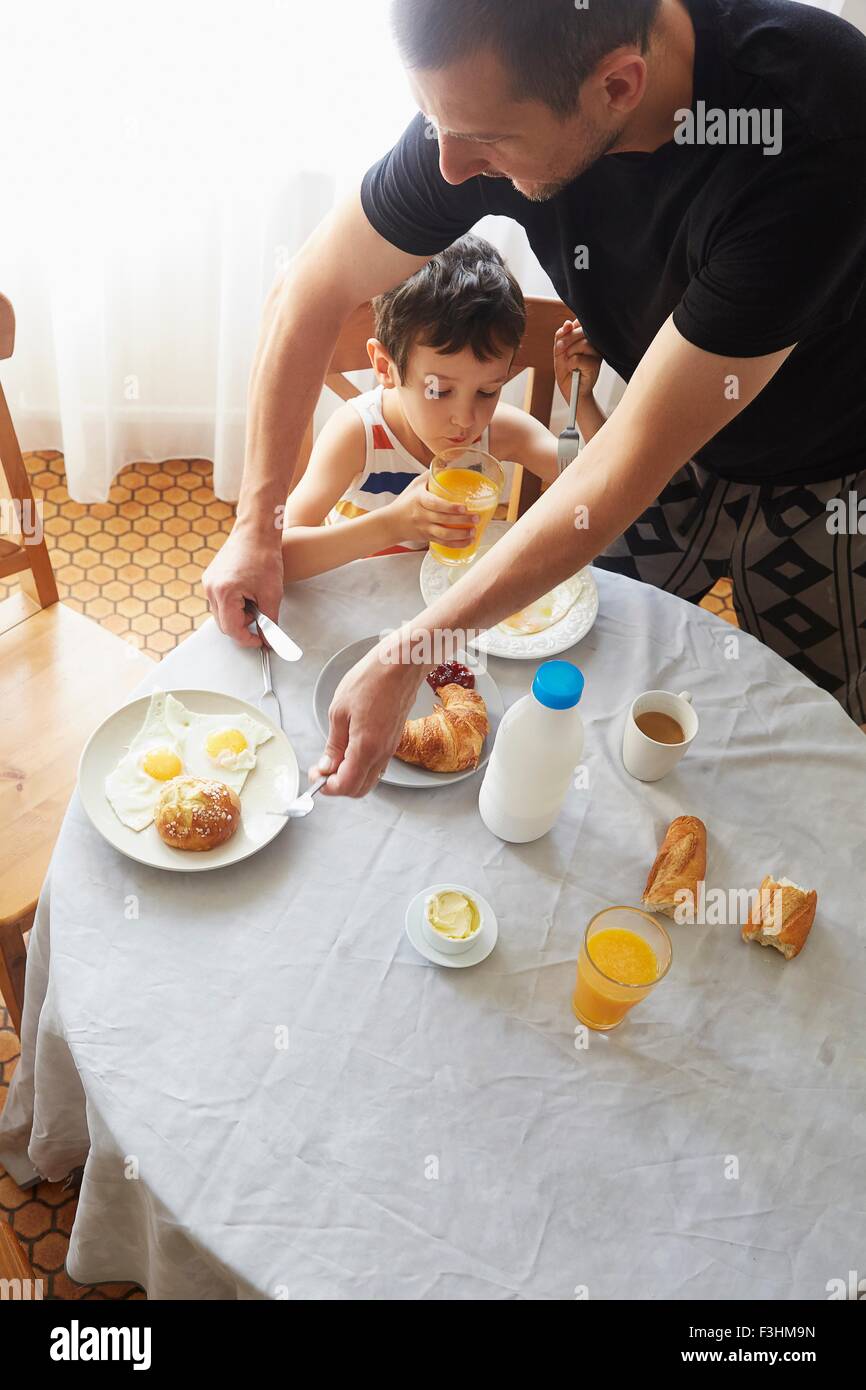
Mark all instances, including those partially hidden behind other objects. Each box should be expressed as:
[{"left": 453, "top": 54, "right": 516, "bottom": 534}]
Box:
[{"left": 0, "top": 449, "right": 737, "bottom": 1298}]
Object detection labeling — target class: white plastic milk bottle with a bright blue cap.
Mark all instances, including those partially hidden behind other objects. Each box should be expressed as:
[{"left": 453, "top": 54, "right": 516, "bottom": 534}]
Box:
[{"left": 478, "top": 662, "right": 584, "bottom": 844}]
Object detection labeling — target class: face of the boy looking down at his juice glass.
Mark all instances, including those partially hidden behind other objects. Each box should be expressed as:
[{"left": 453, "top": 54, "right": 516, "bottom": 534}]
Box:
[{"left": 371, "top": 343, "right": 514, "bottom": 453}]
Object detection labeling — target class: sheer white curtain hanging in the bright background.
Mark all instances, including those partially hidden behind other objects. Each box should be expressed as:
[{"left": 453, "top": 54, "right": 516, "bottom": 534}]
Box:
[{"left": 0, "top": 0, "right": 863, "bottom": 502}]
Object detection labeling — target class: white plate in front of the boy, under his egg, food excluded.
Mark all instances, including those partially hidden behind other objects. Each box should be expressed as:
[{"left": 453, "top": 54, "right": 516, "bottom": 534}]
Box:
[{"left": 421, "top": 521, "right": 598, "bottom": 662}]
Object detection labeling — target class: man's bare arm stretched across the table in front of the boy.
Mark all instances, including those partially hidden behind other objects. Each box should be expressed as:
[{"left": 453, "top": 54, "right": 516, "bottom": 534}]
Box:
[{"left": 322, "top": 318, "right": 795, "bottom": 796}]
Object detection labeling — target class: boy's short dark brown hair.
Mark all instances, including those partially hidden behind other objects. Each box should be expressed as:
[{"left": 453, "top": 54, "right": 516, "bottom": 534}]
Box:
[{"left": 373, "top": 234, "right": 527, "bottom": 379}]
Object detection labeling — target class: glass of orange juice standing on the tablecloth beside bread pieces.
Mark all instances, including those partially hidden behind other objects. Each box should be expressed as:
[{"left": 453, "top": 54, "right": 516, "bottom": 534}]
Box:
[{"left": 571, "top": 908, "right": 671, "bottom": 1033}]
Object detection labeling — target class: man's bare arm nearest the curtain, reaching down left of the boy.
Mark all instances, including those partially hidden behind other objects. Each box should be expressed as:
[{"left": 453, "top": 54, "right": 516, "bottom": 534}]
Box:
[{"left": 204, "top": 193, "right": 428, "bottom": 646}]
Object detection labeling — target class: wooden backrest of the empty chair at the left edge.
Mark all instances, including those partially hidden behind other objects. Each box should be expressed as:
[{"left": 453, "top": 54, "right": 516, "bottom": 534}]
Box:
[{"left": 0, "top": 295, "right": 58, "bottom": 632}]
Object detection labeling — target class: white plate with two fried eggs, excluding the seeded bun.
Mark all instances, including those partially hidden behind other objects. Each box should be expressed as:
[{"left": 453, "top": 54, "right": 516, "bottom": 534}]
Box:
[{"left": 78, "top": 689, "right": 300, "bottom": 872}]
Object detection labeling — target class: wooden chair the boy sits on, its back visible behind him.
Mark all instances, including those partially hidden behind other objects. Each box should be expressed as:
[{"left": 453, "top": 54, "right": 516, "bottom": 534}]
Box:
[{"left": 295, "top": 297, "right": 574, "bottom": 521}]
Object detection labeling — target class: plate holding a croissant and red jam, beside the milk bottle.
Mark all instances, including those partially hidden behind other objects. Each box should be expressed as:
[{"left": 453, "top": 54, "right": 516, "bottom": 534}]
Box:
[{"left": 313, "top": 637, "right": 505, "bottom": 787}]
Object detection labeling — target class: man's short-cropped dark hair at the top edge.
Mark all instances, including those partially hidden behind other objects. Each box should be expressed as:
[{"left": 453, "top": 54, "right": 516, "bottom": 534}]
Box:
[{"left": 392, "top": 0, "right": 662, "bottom": 117}]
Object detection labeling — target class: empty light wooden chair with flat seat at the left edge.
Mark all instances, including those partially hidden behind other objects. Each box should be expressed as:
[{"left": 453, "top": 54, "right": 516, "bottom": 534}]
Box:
[{"left": 0, "top": 295, "right": 152, "bottom": 1033}]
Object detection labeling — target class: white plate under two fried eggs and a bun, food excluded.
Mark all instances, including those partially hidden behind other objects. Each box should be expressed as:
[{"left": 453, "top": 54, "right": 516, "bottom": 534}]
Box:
[{"left": 78, "top": 691, "right": 300, "bottom": 873}]
